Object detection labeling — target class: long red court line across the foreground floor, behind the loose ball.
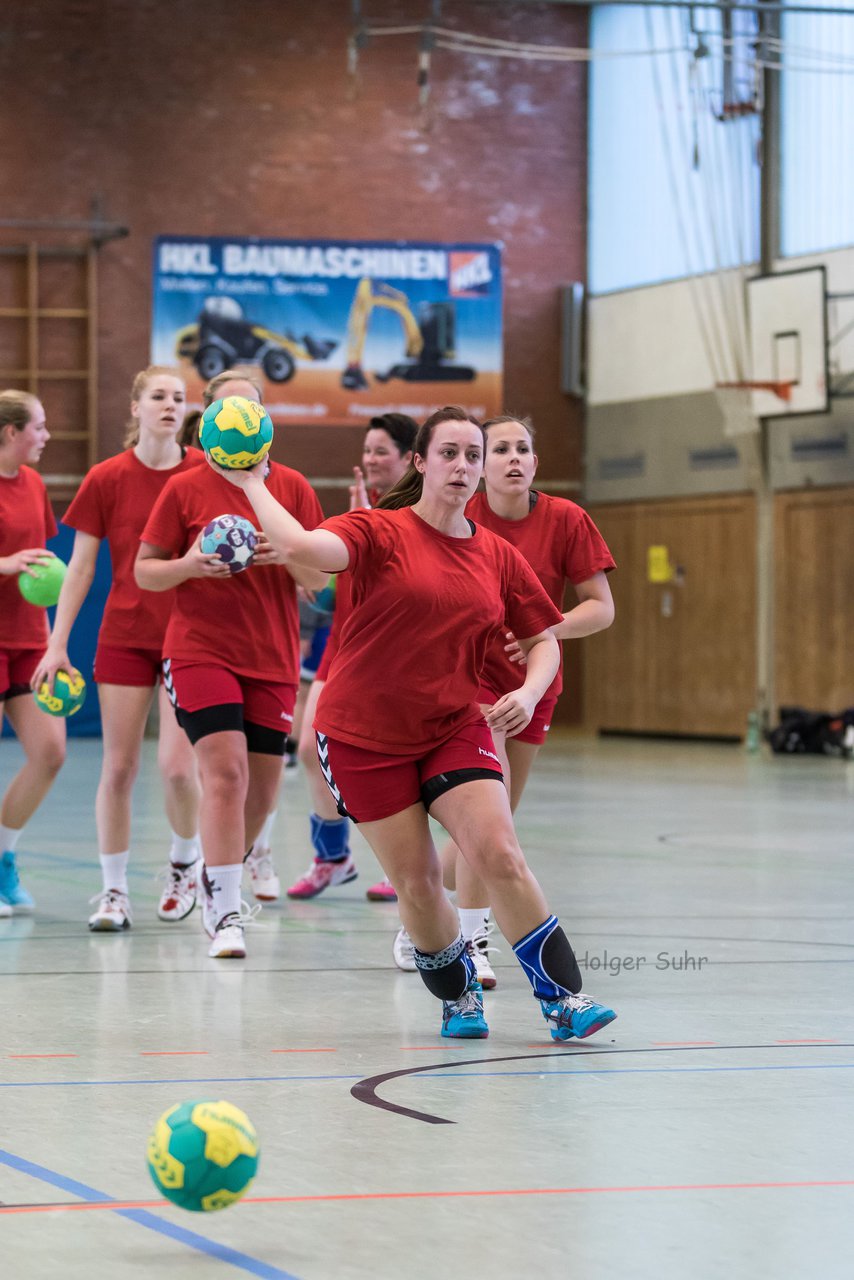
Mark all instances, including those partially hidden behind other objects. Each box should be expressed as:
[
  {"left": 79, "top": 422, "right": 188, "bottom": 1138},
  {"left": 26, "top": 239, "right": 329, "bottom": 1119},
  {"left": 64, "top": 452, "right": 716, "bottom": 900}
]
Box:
[{"left": 0, "top": 1178, "right": 854, "bottom": 1215}]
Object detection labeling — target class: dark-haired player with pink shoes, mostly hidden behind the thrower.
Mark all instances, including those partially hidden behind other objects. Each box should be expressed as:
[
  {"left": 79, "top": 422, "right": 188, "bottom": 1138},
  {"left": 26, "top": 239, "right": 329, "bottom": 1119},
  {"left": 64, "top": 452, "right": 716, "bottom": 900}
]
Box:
[{"left": 288, "top": 413, "right": 417, "bottom": 902}]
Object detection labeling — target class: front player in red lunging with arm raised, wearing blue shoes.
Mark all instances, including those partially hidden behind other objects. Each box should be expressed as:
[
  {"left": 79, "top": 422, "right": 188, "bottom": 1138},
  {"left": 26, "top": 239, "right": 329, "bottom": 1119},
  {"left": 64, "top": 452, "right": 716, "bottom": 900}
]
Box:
[{"left": 213, "top": 406, "right": 616, "bottom": 1041}]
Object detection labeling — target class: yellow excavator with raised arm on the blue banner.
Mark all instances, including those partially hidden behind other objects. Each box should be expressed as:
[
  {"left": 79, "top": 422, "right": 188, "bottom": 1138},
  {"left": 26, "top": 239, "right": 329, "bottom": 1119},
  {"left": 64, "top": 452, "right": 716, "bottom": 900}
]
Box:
[{"left": 341, "top": 279, "right": 476, "bottom": 392}]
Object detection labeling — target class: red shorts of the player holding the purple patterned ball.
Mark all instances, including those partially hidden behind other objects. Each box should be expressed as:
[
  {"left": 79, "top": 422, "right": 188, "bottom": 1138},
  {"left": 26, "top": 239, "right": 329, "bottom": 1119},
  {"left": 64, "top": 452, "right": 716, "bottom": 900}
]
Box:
[{"left": 163, "top": 658, "right": 297, "bottom": 733}]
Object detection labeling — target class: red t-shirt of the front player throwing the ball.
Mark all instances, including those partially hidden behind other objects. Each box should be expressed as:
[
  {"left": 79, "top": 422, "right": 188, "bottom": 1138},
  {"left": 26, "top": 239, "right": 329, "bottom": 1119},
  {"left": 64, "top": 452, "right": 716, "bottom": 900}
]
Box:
[{"left": 315, "top": 507, "right": 561, "bottom": 755}]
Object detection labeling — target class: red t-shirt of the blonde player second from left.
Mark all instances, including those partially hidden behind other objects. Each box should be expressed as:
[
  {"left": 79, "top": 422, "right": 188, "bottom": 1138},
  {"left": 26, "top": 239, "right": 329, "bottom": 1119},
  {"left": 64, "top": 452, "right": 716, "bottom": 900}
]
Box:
[{"left": 63, "top": 449, "right": 205, "bottom": 649}]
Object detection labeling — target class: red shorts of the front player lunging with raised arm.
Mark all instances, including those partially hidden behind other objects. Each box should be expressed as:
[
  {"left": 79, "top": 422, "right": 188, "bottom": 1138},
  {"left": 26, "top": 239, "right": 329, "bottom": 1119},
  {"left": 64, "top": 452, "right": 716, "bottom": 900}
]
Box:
[{"left": 318, "top": 721, "right": 503, "bottom": 822}]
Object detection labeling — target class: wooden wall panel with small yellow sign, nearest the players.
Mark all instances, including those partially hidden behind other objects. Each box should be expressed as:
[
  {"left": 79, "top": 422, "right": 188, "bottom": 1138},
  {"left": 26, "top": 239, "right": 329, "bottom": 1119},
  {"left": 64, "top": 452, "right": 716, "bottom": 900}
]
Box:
[{"left": 584, "top": 494, "right": 755, "bottom": 736}]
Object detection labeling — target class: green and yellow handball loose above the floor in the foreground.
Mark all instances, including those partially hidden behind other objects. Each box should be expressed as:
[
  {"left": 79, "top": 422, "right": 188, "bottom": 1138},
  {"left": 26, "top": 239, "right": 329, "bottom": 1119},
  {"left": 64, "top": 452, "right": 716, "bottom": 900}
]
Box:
[{"left": 146, "top": 1101, "right": 259, "bottom": 1213}]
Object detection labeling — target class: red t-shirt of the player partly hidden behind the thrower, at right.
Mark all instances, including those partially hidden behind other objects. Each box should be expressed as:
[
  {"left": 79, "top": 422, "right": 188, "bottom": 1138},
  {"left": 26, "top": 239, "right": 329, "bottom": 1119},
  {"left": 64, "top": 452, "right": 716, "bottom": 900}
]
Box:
[{"left": 466, "top": 493, "right": 617, "bottom": 696}]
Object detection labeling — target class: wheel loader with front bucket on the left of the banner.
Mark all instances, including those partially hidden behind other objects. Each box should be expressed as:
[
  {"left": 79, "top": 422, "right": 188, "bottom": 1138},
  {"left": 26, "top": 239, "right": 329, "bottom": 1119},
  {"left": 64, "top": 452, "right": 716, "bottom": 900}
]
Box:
[{"left": 175, "top": 296, "right": 338, "bottom": 383}]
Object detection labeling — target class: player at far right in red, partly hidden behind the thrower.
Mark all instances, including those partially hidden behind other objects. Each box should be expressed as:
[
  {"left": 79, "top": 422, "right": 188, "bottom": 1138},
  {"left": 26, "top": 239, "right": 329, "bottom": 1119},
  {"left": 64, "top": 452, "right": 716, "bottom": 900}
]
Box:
[{"left": 407, "top": 416, "right": 615, "bottom": 988}]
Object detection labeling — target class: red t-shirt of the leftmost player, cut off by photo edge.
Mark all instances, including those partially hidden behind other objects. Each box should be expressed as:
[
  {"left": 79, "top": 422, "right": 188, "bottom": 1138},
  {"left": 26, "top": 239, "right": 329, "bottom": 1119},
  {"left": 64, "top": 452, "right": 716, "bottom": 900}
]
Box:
[{"left": 0, "top": 467, "right": 56, "bottom": 649}]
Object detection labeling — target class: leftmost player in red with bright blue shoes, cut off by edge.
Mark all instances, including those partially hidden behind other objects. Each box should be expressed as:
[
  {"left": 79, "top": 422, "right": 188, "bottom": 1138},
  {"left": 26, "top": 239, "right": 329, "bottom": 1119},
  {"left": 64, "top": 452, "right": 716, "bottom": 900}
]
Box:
[{"left": 0, "top": 390, "right": 65, "bottom": 916}]
